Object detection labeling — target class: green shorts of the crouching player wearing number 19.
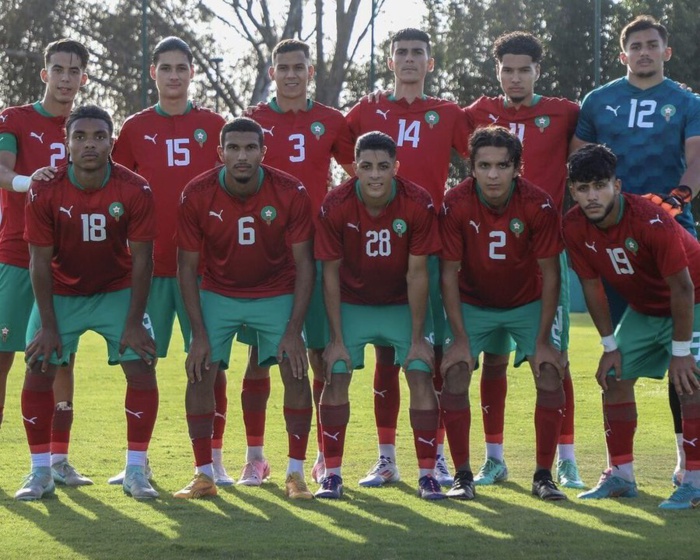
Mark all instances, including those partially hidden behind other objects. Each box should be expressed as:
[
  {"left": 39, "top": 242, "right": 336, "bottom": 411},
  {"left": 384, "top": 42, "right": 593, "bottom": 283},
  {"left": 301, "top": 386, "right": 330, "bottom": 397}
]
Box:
[{"left": 609, "top": 305, "right": 700, "bottom": 379}]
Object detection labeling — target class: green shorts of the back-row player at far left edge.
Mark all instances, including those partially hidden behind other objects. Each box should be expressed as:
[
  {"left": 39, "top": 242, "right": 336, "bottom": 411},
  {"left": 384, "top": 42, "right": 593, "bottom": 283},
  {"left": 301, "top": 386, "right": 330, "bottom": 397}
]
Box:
[{"left": 0, "top": 264, "right": 34, "bottom": 352}]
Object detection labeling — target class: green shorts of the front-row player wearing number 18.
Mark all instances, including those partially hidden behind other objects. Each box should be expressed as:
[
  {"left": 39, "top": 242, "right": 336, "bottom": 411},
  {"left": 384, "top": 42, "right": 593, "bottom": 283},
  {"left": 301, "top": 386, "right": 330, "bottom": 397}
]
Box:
[{"left": 26, "top": 288, "right": 155, "bottom": 366}]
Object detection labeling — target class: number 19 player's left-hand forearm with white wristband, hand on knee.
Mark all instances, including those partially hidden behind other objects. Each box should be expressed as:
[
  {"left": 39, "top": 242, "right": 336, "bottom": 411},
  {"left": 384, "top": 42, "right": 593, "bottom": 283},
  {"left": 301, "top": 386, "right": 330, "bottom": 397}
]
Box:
[{"left": 580, "top": 277, "right": 622, "bottom": 389}]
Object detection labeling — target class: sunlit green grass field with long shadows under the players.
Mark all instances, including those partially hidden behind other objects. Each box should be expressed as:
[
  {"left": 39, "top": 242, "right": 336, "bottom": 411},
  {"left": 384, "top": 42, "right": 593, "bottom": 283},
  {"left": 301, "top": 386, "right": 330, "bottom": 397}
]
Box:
[{"left": 0, "top": 315, "right": 700, "bottom": 560}]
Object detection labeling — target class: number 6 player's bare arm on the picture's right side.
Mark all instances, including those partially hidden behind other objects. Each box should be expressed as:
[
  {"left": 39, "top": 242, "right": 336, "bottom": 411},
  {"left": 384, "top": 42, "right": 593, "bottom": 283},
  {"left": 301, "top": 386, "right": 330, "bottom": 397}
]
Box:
[{"left": 277, "top": 239, "right": 316, "bottom": 379}]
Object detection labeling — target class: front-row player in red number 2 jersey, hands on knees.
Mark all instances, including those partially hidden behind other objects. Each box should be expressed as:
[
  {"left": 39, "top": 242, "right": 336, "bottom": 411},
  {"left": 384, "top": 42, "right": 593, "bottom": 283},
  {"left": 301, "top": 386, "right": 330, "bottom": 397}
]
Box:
[{"left": 440, "top": 126, "right": 566, "bottom": 500}]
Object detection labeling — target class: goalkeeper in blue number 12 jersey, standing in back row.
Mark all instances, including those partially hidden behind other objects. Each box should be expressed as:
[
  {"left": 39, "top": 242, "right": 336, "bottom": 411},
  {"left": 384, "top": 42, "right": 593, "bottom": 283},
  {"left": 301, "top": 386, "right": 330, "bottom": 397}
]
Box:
[{"left": 572, "top": 16, "right": 700, "bottom": 484}]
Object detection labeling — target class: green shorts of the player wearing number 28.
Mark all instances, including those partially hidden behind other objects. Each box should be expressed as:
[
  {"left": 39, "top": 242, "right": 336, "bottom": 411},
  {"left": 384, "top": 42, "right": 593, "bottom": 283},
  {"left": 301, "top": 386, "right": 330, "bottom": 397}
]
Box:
[{"left": 333, "top": 303, "right": 432, "bottom": 373}]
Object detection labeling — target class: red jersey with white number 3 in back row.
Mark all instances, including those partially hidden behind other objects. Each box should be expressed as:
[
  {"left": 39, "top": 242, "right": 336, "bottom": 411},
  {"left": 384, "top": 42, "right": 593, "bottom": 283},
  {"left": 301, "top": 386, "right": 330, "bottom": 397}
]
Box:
[{"left": 251, "top": 99, "right": 354, "bottom": 215}]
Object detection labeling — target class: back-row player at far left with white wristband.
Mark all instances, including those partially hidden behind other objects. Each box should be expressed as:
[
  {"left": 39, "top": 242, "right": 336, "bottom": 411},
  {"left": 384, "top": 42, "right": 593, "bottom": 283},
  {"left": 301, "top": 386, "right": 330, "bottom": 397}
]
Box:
[{"left": 0, "top": 39, "right": 92, "bottom": 486}]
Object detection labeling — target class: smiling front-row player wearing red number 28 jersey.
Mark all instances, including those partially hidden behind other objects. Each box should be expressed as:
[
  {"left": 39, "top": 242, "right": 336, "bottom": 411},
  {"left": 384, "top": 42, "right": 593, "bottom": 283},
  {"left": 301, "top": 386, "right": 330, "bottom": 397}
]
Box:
[{"left": 315, "top": 132, "right": 445, "bottom": 500}]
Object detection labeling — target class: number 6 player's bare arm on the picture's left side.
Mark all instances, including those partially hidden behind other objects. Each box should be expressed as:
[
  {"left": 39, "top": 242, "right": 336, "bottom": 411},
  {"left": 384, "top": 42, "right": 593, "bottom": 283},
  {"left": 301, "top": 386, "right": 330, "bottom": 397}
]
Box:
[{"left": 177, "top": 248, "right": 211, "bottom": 383}]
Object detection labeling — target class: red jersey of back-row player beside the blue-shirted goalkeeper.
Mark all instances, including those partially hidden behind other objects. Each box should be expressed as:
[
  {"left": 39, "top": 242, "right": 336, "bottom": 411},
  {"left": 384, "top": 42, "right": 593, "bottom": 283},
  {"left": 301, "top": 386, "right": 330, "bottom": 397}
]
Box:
[{"left": 464, "top": 95, "right": 579, "bottom": 211}]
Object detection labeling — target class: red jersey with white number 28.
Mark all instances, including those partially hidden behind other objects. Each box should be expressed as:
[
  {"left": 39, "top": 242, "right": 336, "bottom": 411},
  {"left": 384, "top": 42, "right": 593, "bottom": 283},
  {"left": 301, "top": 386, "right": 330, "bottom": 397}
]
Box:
[{"left": 314, "top": 177, "right": 440, "bottom": 305}]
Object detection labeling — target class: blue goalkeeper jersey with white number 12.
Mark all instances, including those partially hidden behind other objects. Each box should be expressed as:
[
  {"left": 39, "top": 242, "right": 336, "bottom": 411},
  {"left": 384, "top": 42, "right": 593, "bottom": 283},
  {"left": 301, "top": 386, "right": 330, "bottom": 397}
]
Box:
[{"left": 576, "top": 78, "right": 700, "bottom": 234}]
